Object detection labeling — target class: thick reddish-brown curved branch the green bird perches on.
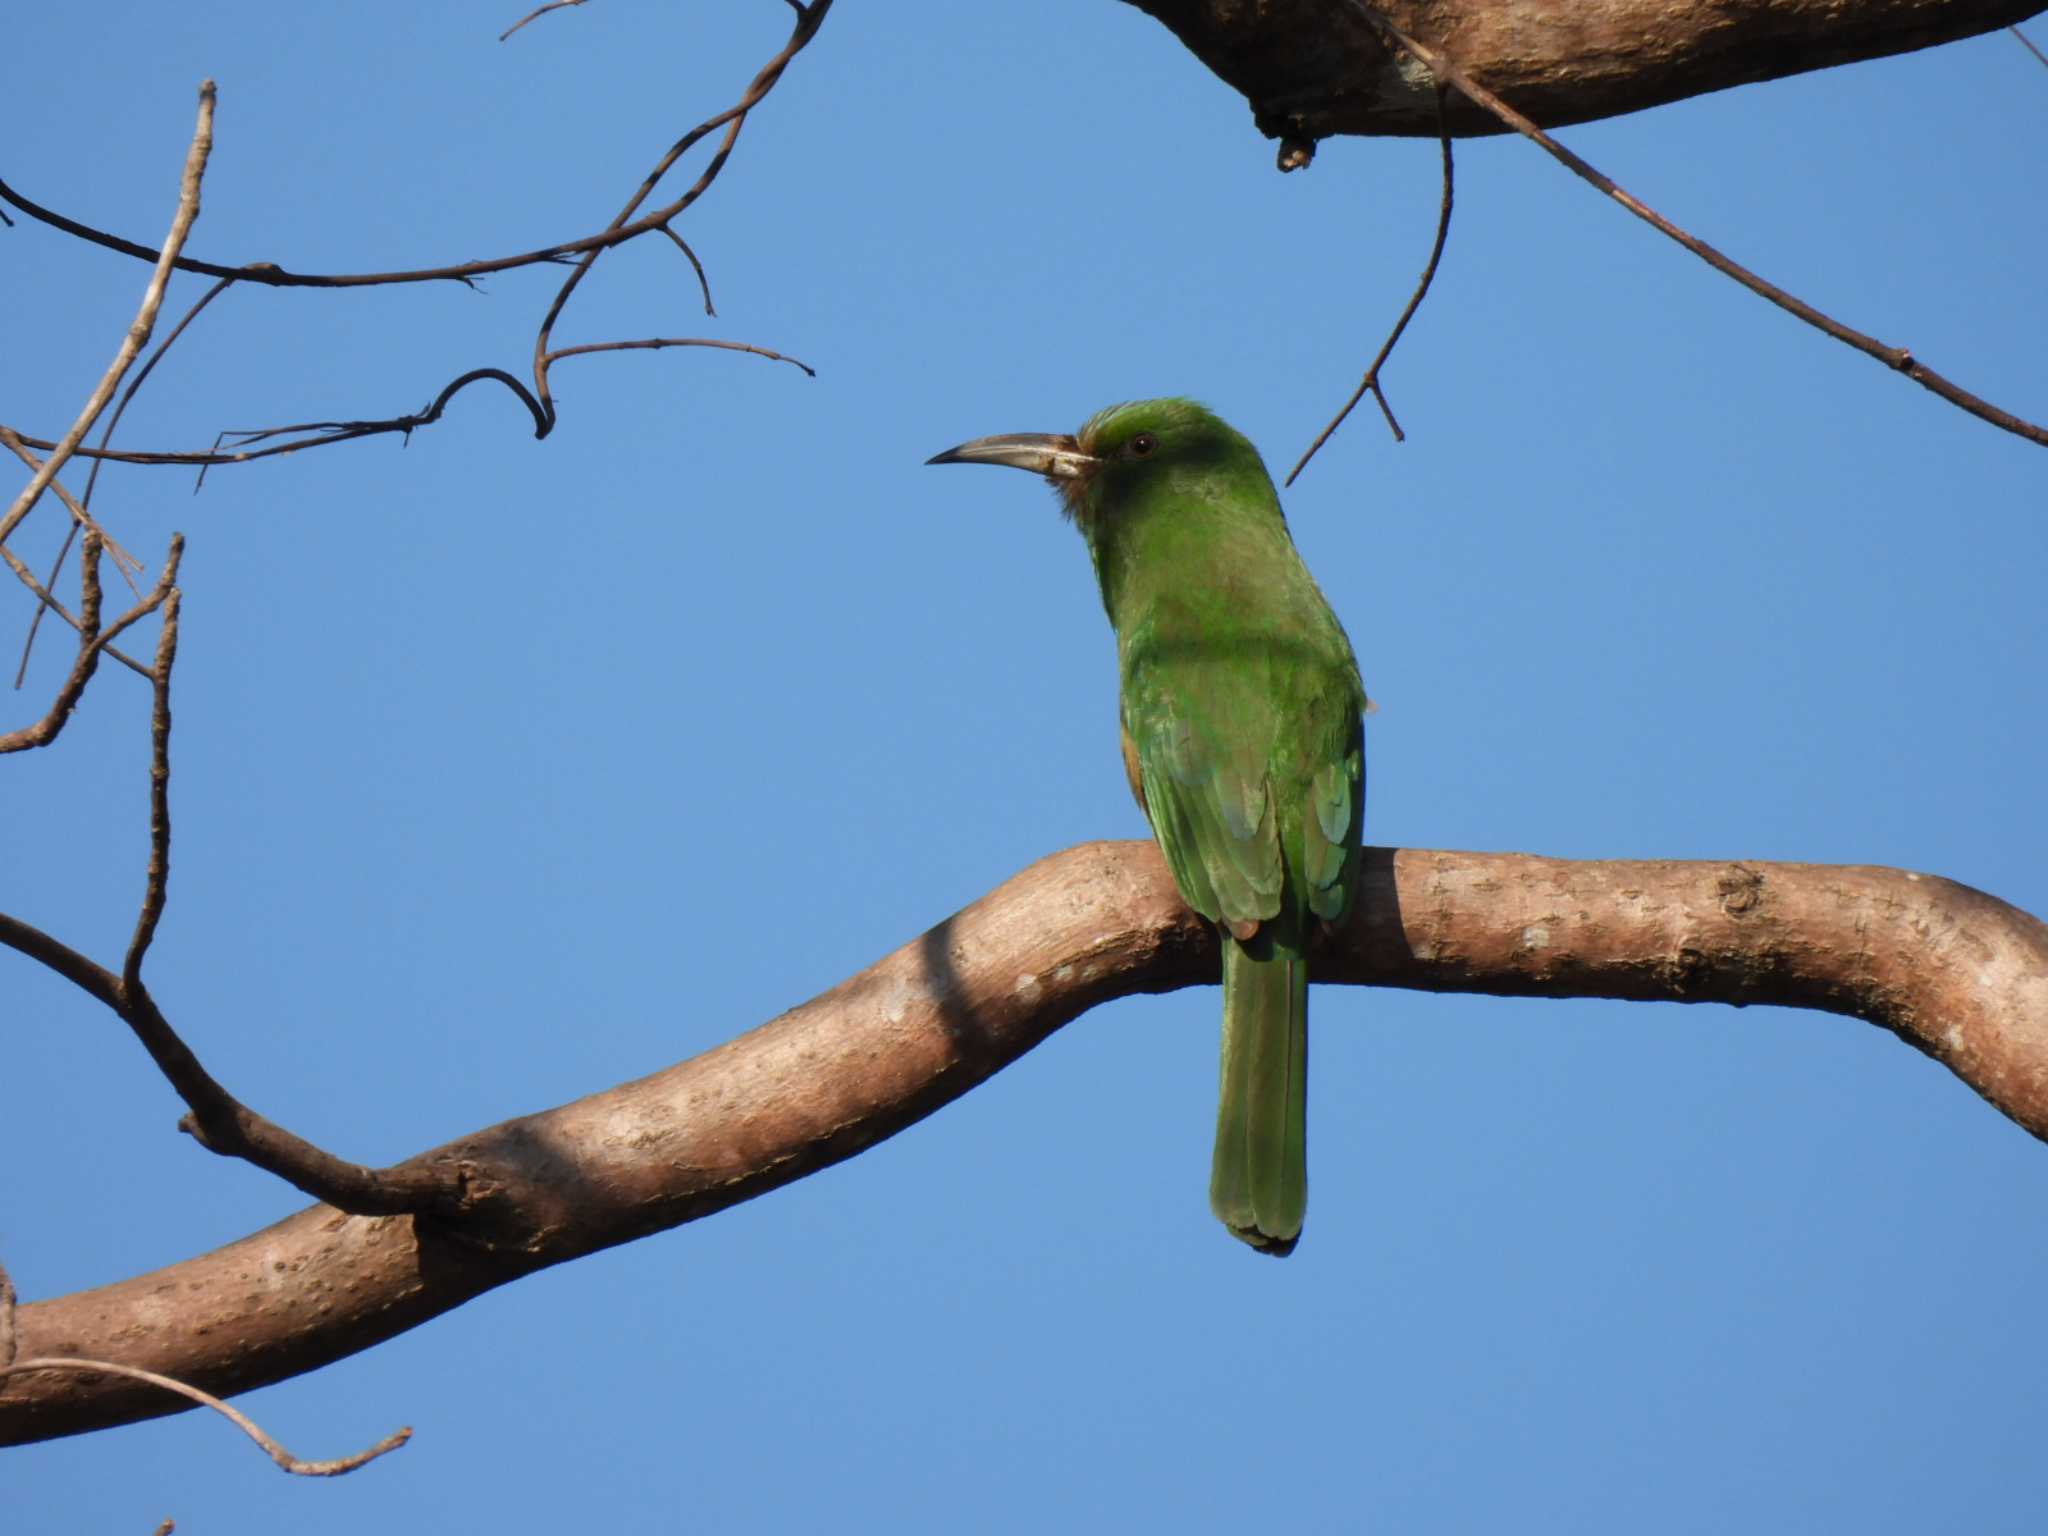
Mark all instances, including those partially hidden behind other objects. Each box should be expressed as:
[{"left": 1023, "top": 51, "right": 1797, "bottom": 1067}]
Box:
[{"left": 0, "top": 842, "right": 2048, "bottom": 1444}]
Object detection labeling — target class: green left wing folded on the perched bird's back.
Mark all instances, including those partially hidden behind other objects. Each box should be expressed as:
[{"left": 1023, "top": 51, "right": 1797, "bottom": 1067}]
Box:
[{"left": 1124, "top": 694, "right": 1286, "bottom": 938}]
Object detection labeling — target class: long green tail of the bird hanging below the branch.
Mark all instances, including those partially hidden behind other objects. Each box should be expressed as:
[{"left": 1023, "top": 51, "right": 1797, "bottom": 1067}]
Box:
[{"left": 1208, "top": 922, "right": 1309, "bottom": 1257}]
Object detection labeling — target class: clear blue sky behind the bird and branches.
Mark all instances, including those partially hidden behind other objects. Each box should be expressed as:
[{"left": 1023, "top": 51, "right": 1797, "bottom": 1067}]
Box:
[{"left": 0, "top": 0, "right": 2048, "bottom": 1532}]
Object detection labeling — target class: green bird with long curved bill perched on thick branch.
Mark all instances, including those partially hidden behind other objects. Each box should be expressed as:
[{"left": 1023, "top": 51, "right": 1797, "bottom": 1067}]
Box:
[{"left": 930, "top": 399, "right": 1370, "bottom": 1255}]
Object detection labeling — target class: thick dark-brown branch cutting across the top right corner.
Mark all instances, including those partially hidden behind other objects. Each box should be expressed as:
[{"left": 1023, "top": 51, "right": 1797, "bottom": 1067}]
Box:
[{"left": 1128, "top": 0, "right": 2042, "bottom": 143}]
